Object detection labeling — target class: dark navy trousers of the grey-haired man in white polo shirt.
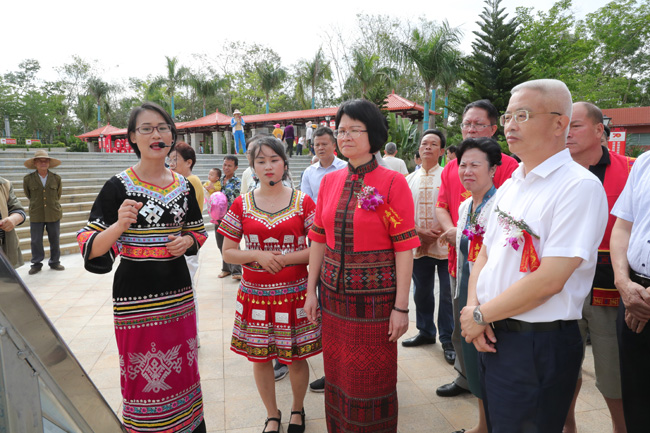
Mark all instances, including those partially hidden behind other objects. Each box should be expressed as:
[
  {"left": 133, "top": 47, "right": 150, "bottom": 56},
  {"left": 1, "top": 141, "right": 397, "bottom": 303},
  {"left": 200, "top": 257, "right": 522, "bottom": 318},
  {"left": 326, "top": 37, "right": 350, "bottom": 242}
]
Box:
[{"left": 479, "top": 321, "right": 582, "bottom": 433}]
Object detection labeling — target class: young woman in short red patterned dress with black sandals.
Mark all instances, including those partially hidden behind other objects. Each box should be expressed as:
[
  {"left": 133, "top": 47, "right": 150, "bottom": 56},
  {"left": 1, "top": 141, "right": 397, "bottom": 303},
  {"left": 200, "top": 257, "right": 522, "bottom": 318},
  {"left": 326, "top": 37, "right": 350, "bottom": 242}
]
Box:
[{"left": 219, "top": 136, "right": 321, "bottom": 433}]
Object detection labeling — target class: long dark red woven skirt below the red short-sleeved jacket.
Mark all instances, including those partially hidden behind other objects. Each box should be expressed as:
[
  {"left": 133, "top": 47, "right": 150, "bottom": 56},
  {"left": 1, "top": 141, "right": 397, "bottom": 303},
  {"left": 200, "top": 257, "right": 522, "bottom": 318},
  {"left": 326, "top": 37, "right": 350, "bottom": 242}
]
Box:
[{"left": 320, "top": 247, "right": 398, "bottom": 433}]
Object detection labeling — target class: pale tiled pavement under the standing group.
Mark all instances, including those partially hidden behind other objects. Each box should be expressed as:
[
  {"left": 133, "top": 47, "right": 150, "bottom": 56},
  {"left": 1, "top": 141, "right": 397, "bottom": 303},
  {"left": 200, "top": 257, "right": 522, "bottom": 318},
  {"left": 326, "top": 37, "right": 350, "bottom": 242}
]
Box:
[{"left": 18, "top": 241, "right": 611, "bottom": 433}]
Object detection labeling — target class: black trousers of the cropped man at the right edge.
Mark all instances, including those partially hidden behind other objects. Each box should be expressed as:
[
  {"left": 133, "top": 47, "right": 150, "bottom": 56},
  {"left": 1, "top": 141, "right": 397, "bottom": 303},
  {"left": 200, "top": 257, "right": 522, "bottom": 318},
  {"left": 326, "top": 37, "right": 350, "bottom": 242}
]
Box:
[{"left": 616, "top": 299, "right": 650, "bottom": 433}]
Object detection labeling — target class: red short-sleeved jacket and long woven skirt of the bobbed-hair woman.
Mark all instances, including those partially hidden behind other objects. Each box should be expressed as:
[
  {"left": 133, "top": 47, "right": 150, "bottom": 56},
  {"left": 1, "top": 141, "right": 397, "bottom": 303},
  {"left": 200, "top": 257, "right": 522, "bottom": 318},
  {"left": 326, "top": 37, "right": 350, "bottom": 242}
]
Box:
[{"left": 309, "top": 158, "right": 420, "bottom": 433}]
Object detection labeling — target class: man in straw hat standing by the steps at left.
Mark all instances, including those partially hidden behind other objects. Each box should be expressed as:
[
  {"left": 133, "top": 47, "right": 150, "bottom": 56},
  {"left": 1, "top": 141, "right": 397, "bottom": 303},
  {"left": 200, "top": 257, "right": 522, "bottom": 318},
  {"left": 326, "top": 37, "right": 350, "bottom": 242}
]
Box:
[{"left": 23, "top": 149, "right": 65, "bottom": 275}]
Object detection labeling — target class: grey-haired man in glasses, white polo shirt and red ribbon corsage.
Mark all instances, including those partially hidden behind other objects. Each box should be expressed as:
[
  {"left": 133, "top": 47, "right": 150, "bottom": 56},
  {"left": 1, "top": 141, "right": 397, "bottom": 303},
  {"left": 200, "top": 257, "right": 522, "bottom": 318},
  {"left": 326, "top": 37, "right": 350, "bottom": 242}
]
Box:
[{"left": 461, "top": 80, "right": 607, "bottom": 433}]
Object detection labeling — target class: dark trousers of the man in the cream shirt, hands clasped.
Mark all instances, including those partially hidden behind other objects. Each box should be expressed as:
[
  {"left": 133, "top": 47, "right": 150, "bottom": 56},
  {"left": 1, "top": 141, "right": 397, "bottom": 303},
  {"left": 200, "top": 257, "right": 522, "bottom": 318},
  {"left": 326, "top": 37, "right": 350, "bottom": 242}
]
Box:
[{"left": 413, "top": 257, "right": 454, "bottom": 343}]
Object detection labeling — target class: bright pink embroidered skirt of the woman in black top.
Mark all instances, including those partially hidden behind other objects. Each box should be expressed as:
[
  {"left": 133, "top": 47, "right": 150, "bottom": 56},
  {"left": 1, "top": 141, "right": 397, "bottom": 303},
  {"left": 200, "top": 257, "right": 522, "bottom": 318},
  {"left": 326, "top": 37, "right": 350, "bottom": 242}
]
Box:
[{"left": 113, "top": 287, "right": 203, "bottom": 432}]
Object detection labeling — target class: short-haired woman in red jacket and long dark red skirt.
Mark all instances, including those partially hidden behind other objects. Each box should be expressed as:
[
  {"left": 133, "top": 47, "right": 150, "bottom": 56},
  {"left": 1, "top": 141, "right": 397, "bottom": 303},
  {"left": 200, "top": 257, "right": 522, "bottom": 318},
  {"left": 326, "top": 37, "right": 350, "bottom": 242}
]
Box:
[{"left": 305, "top": 100, "right": 420, "bottom": 433}]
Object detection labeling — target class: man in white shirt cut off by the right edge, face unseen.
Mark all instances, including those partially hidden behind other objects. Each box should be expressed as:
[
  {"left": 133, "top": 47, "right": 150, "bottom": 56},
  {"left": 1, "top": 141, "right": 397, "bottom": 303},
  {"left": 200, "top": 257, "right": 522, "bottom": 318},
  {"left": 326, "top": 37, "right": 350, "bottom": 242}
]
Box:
[{"left": 609, "top": 148, "right": 650, "bottom": 433}]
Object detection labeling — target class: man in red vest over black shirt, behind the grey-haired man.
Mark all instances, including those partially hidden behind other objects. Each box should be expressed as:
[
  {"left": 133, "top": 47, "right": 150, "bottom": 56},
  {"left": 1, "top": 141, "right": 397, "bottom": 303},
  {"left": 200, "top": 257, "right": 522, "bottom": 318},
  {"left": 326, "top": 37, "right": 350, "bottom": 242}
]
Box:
[{"left": 564, "top": 102, "right": 634, "bottom": 433}]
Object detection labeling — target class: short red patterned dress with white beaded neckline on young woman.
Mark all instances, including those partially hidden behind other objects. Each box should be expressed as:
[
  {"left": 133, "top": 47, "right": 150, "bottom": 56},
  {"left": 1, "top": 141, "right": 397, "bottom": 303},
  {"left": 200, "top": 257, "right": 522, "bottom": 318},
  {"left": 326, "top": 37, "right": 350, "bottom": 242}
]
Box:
[{"left": 218, "top": 190, "right": 322, "bottom": 364}]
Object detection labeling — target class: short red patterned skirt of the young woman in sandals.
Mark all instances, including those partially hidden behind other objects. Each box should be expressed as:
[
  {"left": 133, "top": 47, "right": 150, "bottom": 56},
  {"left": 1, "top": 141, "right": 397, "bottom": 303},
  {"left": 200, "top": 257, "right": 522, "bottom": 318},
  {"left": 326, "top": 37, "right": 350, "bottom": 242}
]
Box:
[{"left": 230, "top": 282, "right": 322, "bottom": 364}]
